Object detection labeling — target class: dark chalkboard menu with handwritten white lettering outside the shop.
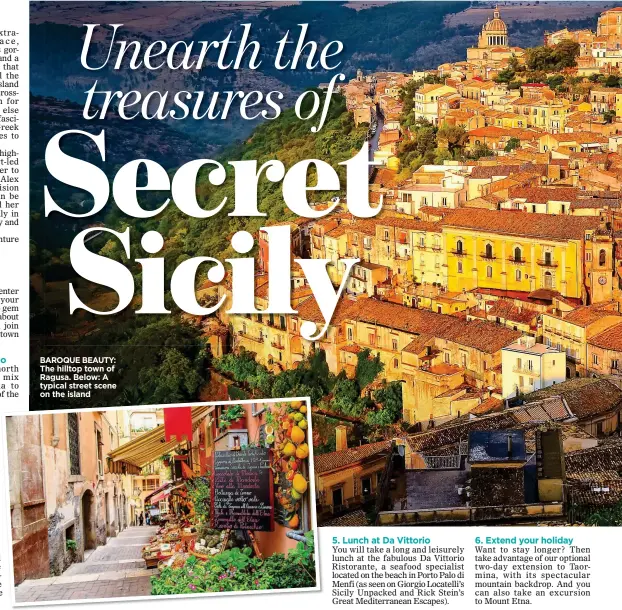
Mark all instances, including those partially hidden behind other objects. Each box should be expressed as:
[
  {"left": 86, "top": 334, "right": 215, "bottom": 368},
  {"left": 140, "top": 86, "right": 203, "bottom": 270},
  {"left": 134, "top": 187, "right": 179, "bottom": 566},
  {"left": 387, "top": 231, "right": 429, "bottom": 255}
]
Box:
[{"left": 212, "top": 447, "right": 274, "bottom": 532}]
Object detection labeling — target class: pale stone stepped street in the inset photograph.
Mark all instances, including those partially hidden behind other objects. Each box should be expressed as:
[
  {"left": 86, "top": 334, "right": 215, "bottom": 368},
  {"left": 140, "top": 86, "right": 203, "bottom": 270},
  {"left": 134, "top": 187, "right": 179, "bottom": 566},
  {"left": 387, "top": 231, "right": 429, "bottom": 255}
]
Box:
[{"left": 15, "top": 526, "right": 158, "bottom": 603}]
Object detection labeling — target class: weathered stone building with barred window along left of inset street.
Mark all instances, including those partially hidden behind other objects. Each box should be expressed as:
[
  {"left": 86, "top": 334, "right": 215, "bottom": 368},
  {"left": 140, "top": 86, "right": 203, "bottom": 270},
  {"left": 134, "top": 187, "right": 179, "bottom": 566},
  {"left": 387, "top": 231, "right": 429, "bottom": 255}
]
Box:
[{"left": 7, "top": 410, "right": 129, "bottom": 584}]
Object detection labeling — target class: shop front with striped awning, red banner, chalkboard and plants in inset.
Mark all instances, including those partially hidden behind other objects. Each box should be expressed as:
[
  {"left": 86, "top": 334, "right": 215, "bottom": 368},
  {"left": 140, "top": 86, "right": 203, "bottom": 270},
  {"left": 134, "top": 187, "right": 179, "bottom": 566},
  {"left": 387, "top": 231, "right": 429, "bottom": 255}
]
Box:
[{"left": 108, "top": 401, "right": 315, "bottom": 594}]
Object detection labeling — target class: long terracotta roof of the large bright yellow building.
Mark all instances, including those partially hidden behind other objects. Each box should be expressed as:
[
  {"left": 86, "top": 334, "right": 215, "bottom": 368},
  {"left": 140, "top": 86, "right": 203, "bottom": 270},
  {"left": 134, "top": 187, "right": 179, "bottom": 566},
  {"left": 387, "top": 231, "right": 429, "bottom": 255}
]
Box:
[{"left": 445, "top": 208, "right": 600, "bottom": 241}]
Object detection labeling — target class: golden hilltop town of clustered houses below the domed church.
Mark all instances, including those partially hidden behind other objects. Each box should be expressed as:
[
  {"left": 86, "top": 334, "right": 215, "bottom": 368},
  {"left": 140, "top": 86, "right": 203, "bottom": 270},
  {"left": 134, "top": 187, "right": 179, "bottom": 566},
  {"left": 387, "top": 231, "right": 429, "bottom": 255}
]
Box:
[{"left": 183, "top": 8, "right": 622, "bottom": 525}]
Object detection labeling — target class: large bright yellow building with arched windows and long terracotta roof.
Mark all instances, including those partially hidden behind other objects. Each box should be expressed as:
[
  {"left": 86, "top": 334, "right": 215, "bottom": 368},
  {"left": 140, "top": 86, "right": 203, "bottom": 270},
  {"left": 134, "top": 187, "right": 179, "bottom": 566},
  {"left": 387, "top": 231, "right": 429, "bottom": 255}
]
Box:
[{"left": 443, "top": 209, "right": 599, "bottom": 299}]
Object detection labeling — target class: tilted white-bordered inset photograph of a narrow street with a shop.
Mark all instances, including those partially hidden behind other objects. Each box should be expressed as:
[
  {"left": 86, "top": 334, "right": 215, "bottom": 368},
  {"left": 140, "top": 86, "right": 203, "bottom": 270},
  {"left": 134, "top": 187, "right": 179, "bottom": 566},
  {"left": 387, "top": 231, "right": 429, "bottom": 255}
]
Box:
[{"left": 4, "top": 399, "right": 318, "bottom": 604}]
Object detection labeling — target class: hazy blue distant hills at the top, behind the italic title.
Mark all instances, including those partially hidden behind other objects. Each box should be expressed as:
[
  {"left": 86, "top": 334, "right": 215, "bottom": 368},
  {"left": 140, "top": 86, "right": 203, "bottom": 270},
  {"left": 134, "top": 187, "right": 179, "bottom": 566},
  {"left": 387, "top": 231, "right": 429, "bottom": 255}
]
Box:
[{"left": 31, "top": 2, "right": 601, "bottom": 146}]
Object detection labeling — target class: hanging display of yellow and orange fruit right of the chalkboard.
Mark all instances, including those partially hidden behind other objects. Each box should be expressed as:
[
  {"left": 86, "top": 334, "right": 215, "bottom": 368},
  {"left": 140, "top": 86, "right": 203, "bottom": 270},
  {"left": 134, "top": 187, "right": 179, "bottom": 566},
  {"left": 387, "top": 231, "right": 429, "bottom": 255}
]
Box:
[{"left": 265, "top": 401, "right": 309, "bottom": 529}]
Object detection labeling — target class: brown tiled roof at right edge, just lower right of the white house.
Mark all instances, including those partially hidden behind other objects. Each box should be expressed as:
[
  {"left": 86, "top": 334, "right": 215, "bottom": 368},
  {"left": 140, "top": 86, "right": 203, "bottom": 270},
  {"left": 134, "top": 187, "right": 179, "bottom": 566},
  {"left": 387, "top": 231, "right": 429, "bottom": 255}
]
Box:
[{"left": 524, "top": 378, "right": 622, "bottom": 420}]
